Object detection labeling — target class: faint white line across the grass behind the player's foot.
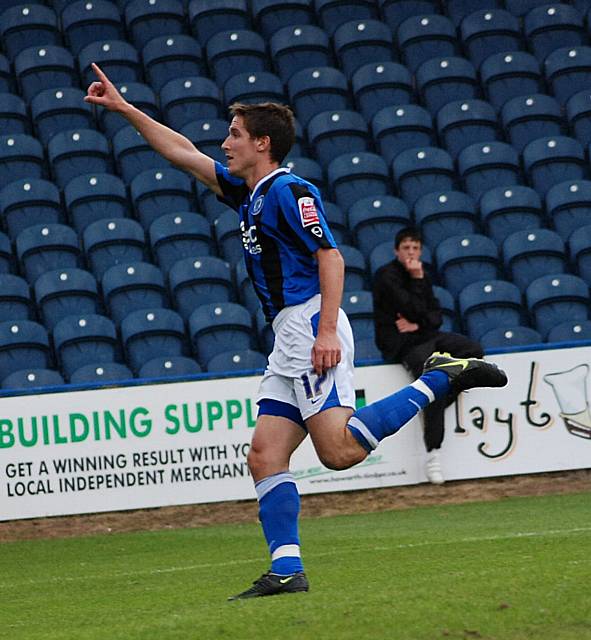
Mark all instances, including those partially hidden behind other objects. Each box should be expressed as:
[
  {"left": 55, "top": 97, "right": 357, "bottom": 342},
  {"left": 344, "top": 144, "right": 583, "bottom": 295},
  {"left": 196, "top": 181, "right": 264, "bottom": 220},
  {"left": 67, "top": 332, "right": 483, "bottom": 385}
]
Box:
[{"left": 0, "top": 526, "right": 591, "bottom": 589}]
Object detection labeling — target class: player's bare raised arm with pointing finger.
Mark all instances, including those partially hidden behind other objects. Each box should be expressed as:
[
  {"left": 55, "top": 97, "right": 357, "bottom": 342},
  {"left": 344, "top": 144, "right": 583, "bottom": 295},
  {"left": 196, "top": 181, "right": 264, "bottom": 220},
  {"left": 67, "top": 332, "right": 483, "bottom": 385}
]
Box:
[{"left": 84, "top": 63, "right": 221, "bottom": 194}]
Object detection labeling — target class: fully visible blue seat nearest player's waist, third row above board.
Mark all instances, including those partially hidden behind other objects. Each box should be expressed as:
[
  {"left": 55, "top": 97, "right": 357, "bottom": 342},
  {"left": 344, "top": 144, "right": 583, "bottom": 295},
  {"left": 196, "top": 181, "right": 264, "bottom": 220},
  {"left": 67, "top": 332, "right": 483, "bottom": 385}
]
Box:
[{"left": 168, "top": 255, "right": 234, "bottom": 320}]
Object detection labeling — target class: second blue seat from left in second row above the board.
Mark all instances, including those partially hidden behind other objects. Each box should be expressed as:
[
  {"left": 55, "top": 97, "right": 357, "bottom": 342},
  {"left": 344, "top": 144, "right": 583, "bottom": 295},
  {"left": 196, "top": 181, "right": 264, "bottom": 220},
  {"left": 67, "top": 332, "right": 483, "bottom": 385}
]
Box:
[{"left": 53, "top": 314, "right": 121, "bottom": 380}]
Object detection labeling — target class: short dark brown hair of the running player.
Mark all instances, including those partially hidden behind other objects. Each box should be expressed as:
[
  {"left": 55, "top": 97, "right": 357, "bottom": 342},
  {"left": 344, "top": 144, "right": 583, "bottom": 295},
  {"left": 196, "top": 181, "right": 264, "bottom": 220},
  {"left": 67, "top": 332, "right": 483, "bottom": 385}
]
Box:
[{"left": 229, "top": 102, "right": 295, "bottom": 164}]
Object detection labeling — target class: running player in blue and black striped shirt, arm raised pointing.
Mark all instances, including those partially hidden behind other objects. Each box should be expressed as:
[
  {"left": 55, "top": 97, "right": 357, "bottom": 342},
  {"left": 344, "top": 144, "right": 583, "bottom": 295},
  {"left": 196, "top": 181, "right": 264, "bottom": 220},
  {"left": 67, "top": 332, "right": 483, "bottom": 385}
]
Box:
[{"left": 85, "top": 65, "right": 507, "bottom": 600}]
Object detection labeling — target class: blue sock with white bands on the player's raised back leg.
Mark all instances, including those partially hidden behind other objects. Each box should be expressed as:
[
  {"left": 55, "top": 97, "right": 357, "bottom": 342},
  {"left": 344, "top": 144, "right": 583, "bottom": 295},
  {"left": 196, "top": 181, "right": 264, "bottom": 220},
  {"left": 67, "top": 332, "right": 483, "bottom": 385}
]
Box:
[{"left": 347, "top": 371, "right": 449, "bottom": 452}]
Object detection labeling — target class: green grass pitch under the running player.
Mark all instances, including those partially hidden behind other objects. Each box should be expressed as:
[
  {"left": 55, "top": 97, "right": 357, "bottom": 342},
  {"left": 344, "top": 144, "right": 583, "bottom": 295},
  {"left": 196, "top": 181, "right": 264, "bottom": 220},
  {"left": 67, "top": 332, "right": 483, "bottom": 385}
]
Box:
[{"left": 0, "top": 493, "right": 591, "bottom": 640}]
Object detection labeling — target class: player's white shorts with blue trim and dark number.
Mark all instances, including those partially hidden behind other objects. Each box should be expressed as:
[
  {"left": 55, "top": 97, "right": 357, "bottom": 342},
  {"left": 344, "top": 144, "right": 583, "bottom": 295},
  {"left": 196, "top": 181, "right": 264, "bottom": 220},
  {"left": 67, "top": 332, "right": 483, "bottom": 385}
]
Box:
[{"left": 257, "top": 294, "right": 355, "bottom": 420}]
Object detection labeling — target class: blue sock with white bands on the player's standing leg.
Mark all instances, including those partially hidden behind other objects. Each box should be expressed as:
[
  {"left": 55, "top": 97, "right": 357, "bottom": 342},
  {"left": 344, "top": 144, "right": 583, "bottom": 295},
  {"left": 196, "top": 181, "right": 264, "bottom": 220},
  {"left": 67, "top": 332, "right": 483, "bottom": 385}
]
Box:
[{"left": 255, "top": 471, "right": 304, "bottom": 576}]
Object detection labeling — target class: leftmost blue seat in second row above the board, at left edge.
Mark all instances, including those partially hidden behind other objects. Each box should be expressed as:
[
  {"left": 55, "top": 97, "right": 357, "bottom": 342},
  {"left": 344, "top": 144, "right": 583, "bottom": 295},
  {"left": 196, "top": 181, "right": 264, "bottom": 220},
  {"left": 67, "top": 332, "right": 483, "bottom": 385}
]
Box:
[{"left": 0, "top": 320, "right": 51, "bottom": 380}]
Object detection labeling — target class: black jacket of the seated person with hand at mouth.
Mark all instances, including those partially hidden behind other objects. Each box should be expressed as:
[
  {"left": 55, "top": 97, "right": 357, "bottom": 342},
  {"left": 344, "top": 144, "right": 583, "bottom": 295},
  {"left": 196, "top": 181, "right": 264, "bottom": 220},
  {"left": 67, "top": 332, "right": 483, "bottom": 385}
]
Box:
[{"left": 373, "top": 260, "right": 442, "bottom": 362}]
